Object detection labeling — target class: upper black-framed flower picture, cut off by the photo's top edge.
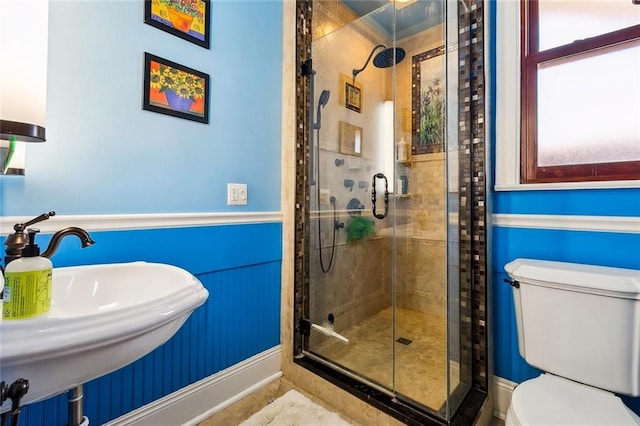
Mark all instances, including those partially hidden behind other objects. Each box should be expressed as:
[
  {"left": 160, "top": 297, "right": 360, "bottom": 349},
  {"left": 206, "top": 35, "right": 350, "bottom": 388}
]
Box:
[{"left": 144, "top": 0, "right": 211, "bottom": 49}]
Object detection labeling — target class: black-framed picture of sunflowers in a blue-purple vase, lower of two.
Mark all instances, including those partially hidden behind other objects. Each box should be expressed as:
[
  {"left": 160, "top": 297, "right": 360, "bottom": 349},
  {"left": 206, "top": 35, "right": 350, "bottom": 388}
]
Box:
[{"left": 142, "top": 52, "right": 210, "bottom": 124}]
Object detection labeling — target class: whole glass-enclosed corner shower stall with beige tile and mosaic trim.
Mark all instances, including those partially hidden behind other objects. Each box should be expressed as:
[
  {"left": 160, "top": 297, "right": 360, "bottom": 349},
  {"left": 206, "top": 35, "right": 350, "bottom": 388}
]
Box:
[{"left": 294, "top": 0, "right": 486, "bottom": 424}]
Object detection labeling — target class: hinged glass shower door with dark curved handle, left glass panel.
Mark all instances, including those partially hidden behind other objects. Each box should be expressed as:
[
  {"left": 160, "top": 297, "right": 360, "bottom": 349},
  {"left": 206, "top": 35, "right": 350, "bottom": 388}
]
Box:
[{"left": 307, "top": 3, "right": 394, "bottom": 391}]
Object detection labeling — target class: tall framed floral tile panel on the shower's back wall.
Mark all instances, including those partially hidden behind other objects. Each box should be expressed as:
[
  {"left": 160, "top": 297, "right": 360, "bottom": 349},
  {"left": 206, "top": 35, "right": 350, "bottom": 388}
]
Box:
[{"left": 411, "top": 46, "right": 446, "bottom": 155}]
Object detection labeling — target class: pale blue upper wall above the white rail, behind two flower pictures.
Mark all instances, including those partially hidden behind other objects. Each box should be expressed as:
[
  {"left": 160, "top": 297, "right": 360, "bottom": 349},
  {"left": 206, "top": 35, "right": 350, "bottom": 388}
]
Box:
[{"left": 0, "top": 0, "right": 282, "bottom": 216}]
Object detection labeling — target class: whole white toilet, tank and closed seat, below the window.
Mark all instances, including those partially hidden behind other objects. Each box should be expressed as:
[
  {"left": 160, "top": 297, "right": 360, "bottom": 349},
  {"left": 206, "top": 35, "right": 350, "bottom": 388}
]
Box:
[{"left": 504, "top": 259, "right": 640, "bottom": 426}]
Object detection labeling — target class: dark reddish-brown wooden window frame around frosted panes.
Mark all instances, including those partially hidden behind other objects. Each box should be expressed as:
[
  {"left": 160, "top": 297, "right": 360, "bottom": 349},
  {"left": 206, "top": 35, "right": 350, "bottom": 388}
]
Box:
[{"left": 520, "top": 0, "right": 640, "bottom": 184}]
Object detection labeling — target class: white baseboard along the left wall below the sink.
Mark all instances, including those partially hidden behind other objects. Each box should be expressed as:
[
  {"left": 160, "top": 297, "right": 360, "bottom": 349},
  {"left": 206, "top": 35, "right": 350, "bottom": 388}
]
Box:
[{"left": 106, "top": 345, "right": 282, "bottom": 426}]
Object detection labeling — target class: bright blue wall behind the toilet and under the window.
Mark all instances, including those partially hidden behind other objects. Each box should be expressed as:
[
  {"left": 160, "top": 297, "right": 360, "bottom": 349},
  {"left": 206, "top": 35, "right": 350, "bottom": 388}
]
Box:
[{"left": 489, "top": 0, "right": 640, "bottom": 413}]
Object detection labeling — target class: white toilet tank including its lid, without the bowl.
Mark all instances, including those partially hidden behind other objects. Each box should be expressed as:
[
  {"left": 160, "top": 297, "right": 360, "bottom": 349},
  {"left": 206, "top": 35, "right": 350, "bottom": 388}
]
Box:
[{"left": 504, "top": 259, "right": 640, "bottom": 396}]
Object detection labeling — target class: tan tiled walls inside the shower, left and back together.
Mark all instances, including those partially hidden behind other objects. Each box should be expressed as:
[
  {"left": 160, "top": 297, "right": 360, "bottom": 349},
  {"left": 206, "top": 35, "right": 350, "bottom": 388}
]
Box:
[{"left": 307, "top": 1, "right": 447, "bottom": 329}]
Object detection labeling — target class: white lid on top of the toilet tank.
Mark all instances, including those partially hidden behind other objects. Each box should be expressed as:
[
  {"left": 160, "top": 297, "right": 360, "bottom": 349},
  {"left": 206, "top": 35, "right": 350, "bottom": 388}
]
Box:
[{"left": 504, "top": 259, "right": 640, "bottom": 299}]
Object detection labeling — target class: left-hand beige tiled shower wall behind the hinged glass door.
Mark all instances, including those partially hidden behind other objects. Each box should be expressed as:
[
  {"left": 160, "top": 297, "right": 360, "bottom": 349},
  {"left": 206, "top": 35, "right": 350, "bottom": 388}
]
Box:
[{"left": 306, "top": 1, "right": 391, "bottom": 331}]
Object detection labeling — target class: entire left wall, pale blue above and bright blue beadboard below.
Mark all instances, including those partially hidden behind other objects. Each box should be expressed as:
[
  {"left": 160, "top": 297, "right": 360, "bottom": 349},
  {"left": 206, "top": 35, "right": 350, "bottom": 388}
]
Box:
[{"left": 0, "top": 0, "right": 282, "bottom": 426}]
